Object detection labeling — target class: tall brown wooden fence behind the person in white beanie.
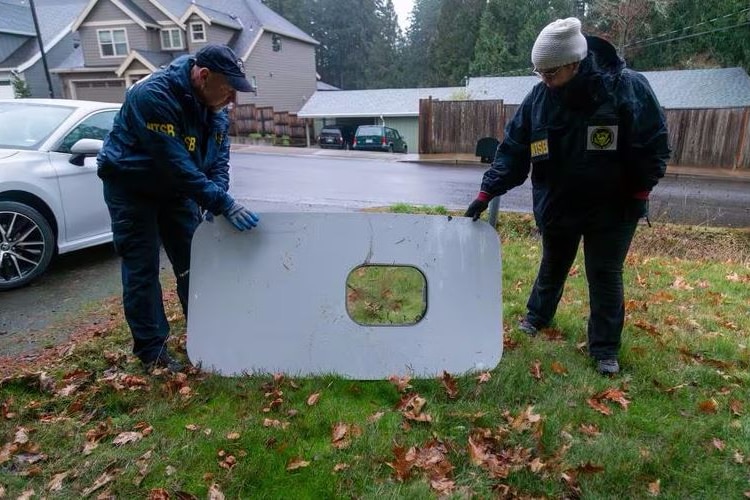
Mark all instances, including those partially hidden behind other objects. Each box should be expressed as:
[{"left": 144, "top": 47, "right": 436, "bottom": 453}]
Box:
[{"left": 419, "top": 99, "right": 750, "bottom": 170}]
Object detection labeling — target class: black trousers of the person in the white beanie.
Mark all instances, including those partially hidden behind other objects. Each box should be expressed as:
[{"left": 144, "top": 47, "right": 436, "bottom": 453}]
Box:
[{"left": 527, "top": 218, "right": 637, "bottom": 359}]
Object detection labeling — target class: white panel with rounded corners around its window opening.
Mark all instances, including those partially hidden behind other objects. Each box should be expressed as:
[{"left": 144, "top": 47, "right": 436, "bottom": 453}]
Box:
[{"left": 187, "top": 213, "right": 503, "bottom": 379}]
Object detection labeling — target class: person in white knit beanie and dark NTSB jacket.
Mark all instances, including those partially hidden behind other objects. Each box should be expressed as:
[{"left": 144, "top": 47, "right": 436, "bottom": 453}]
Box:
[{"left": 465, "top": 18, "right": 669, "bottom": 374}]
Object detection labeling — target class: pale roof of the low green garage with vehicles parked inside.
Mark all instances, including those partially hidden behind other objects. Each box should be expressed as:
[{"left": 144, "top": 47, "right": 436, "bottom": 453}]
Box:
[{"left": 297, "top": 87, "right": 464, "bottom": 118}]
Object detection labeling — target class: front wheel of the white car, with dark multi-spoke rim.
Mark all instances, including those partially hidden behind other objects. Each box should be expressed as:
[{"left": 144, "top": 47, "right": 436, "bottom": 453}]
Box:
[{"left": 0, "top": 201, "right": 55, "bottom": 290}]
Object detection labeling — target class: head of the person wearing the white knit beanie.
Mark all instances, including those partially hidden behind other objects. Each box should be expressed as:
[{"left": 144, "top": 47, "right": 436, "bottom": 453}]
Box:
[{"left": 531, "top": 17, "right": 588, "bottom": 87}]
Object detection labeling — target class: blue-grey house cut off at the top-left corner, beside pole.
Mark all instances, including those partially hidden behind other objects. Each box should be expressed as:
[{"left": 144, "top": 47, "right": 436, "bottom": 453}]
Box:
[{"left": 0, "top": 0, "right": 87, "bottom": 98}]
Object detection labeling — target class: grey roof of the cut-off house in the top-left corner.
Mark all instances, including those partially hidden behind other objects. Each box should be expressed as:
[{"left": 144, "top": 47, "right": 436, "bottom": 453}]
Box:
[{"left": 0, "top": 0, "right": 87, "bottom": 71}]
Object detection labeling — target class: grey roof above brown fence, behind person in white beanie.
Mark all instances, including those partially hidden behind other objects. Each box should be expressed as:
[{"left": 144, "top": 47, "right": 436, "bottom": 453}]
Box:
[{"left": 466, "top": 68, "right": 750, "bottom": 109}]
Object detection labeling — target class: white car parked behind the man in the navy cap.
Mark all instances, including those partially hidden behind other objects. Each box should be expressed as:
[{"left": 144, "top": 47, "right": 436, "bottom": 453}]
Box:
[{"left": 0, "top": 99, "right": 120, "bottom": 291}]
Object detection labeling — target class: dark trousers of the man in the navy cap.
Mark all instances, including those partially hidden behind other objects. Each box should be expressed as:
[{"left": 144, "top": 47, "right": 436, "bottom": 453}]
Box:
[{"left": 104, "top": 180, "right": 201, "bottom": 362}]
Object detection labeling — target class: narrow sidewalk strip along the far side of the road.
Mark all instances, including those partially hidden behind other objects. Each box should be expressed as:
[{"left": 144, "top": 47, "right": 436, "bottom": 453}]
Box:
[{"left": 232, "top": 144, "right": 750, "bottom": 183}]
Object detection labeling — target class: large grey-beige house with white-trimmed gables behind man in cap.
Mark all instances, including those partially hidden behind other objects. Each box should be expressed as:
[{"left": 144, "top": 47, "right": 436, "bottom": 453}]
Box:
[{"left": 52, "top": 0, "right": 318, "bottom": 113}]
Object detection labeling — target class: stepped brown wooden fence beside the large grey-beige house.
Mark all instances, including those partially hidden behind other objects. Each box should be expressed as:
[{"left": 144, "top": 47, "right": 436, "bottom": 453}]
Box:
[{"left": 229, "top": 104, "right": 306, "bottom": 144}]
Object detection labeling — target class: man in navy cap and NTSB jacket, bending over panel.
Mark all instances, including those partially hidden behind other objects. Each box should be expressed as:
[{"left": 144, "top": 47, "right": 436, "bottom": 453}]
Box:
[{"left": 97, "top": 45, "right": 258, "bottom": 371}]
